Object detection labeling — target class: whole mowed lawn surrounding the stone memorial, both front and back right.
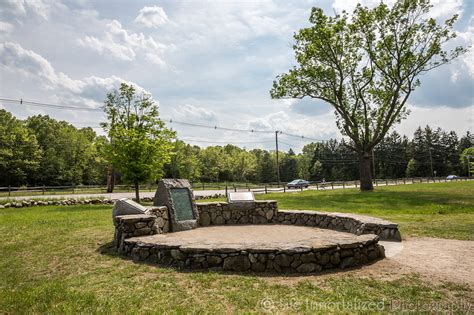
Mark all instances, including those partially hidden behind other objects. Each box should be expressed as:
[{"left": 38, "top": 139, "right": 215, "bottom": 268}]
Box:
[{"left": 0, "top": 182, "right": 474, "bottom": 314}]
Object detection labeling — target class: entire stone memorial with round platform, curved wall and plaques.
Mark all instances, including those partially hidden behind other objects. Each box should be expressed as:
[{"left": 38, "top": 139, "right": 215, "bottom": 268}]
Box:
[{"left": 113, "top": 179, "right": 401, "bottom": 273}]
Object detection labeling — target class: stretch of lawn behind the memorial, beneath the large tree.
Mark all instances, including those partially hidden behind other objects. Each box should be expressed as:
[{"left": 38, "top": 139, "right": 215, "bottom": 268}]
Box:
[{"left": 257, "top": 181, "right": 474, "bottom": 240}]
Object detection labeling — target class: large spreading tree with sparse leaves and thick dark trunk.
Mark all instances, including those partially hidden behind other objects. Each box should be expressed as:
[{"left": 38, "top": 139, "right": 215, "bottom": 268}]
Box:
[{"left": 270, "top": 0, "right": 466, "bottom": 190}]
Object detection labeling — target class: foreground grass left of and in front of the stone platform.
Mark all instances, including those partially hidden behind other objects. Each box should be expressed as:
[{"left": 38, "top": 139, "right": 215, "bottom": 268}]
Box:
[{"left": 0, "top": 205, "right": 472, "bottom": 313}]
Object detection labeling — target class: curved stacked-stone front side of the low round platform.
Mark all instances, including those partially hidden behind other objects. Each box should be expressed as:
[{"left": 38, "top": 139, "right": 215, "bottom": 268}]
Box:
[{"left": 120, "top": 235, "right": 385, "bottom": 273}]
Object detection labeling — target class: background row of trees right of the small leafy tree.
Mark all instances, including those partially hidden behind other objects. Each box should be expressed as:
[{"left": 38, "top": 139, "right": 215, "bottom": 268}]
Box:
[{"left": 165, "top": 126, "right": 474, "bottom": 183}]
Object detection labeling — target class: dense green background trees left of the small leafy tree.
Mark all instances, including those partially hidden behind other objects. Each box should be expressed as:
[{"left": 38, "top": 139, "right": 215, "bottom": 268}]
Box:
[{"left": 0, "top": 110, "right": 106, "bottom": 186}]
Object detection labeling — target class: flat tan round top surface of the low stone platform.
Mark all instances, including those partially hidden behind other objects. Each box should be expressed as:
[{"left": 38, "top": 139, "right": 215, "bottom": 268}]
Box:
[{"left": 125, "top": 224, "right": 378, "bottom": 253}]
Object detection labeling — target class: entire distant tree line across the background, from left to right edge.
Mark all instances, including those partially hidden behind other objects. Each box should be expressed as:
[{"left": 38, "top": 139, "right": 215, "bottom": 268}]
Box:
[{"left": 0, "top": 110, "right": 474, "bottom": 186}]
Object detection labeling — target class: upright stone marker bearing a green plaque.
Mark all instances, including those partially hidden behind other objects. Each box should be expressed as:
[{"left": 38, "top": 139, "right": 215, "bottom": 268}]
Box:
[{"left": 153, "top": 179, "right": 198, "bottom": 232}]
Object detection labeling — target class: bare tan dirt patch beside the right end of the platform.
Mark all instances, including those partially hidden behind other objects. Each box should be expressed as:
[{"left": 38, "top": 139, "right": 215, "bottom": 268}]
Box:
[{"left": 266, "top": 237, "right": 474, "bottom": 289}]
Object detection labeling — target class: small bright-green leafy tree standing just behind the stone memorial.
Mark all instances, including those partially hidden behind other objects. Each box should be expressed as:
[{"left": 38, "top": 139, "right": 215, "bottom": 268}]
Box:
[{"left": 102, "top": 83, "right": 175, "bottom": 202}]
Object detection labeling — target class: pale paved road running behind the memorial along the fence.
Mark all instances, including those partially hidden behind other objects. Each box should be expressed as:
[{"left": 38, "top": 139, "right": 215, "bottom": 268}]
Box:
[{"left": 0, "top": 179, "right": 466, "bottom": 200}]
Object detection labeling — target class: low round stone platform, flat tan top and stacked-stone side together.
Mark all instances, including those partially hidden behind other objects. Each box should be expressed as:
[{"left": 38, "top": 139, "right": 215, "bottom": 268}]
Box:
[{"left": 123, "top": 225, "right": 384, "bottom": 273}]
